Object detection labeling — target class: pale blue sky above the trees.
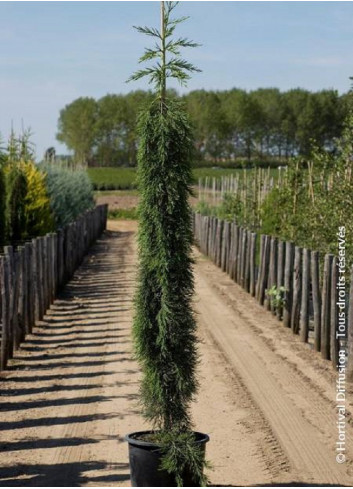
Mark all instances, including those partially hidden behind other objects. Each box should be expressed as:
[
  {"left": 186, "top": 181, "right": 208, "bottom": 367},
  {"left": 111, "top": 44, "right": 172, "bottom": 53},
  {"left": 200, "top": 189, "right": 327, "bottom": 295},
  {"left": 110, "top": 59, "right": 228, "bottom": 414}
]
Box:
[{"left": 0, "top": 1, "right": 353, "bottom": 159}]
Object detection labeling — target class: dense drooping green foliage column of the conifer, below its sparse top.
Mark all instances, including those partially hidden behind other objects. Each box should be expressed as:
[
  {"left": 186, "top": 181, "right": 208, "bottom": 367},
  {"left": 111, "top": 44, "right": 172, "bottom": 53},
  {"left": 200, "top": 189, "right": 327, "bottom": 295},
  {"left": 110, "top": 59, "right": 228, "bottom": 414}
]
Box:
[{"left": 134, "top": 97, "right": 197, "bottom": 431}]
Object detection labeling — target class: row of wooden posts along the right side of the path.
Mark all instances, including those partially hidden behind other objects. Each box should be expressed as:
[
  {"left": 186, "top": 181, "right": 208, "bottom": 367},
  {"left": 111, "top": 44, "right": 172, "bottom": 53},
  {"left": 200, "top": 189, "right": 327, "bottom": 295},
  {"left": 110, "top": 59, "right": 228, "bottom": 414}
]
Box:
[{"left": 193, "top": 213, "right": 353, "bottom": 380}]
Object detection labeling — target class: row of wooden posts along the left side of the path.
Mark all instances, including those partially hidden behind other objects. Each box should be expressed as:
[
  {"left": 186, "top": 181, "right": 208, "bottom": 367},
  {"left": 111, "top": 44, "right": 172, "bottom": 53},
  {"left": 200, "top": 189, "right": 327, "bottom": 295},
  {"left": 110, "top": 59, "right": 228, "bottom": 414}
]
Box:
[{"left": 0, "top": 205, "right": 107, "bottom": 370}]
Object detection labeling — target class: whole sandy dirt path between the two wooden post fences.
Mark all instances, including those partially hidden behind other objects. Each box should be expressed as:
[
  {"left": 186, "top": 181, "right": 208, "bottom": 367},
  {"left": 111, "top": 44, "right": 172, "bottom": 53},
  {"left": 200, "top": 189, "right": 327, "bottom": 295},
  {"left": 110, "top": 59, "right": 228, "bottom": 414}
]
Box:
[{"left": 0, "top": 221, "right": 353, "bottom": 487}]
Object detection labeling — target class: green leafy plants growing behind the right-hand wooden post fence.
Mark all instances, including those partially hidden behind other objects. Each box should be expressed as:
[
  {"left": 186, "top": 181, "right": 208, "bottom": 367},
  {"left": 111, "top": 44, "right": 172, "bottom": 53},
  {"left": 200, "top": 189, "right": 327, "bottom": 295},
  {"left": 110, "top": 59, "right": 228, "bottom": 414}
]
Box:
[{"left": 198, "top": 95, "right": 353, "bottom": 266}]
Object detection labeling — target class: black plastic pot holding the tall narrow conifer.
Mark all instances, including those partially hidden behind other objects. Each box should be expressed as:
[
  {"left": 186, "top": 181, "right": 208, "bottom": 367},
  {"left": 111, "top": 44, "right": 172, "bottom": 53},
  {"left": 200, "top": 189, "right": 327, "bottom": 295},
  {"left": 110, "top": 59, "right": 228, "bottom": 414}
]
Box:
[{"left": 125, "top": 431, "right": 210, "bottom": 487}]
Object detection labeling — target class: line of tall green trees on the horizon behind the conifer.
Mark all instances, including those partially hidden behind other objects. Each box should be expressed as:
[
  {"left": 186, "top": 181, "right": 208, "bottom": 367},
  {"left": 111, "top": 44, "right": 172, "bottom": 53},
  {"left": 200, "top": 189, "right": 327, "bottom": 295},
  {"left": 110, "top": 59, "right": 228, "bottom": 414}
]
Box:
[{"left": 57, "top": 88, "right": 348, "bottom": 166}]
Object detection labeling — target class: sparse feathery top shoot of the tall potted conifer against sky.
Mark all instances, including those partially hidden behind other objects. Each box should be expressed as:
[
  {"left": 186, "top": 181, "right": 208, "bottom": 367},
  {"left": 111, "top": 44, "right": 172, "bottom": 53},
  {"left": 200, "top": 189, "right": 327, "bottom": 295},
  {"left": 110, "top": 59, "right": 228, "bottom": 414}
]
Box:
[{"left": 128, "top": 2, "right": 201, "bottom": 101}]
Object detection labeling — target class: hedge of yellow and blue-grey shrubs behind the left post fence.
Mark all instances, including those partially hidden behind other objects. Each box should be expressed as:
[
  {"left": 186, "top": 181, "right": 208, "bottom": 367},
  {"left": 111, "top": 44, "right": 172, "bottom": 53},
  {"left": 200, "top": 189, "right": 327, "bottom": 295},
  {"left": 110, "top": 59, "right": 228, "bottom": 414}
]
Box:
[{"left": 0, "top": 157, "right": 94, "bottom": 246}]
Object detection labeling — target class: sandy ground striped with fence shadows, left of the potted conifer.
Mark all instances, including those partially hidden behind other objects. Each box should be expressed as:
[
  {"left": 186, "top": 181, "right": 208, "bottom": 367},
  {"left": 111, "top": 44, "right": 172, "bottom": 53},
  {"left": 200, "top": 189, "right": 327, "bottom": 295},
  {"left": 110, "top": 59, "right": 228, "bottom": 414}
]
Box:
[{"left": 0, "top": 223, "right": 143, "bottom": 486}]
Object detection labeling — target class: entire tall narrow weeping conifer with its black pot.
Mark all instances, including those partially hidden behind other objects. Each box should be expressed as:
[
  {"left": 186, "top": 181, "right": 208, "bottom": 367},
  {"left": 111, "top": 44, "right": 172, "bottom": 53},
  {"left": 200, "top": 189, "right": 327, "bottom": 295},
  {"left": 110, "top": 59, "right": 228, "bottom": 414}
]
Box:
[{"left": 126, "top": 2, "right": 208, "bottom": 487}]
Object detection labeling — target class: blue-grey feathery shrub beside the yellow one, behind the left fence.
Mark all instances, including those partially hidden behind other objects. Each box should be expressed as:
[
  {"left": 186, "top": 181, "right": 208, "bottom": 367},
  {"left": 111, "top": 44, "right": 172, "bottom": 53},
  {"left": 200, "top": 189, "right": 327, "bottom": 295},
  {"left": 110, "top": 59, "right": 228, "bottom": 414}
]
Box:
[{"left": 40, "top": 164, "right": 94, "bottom": 228}]
